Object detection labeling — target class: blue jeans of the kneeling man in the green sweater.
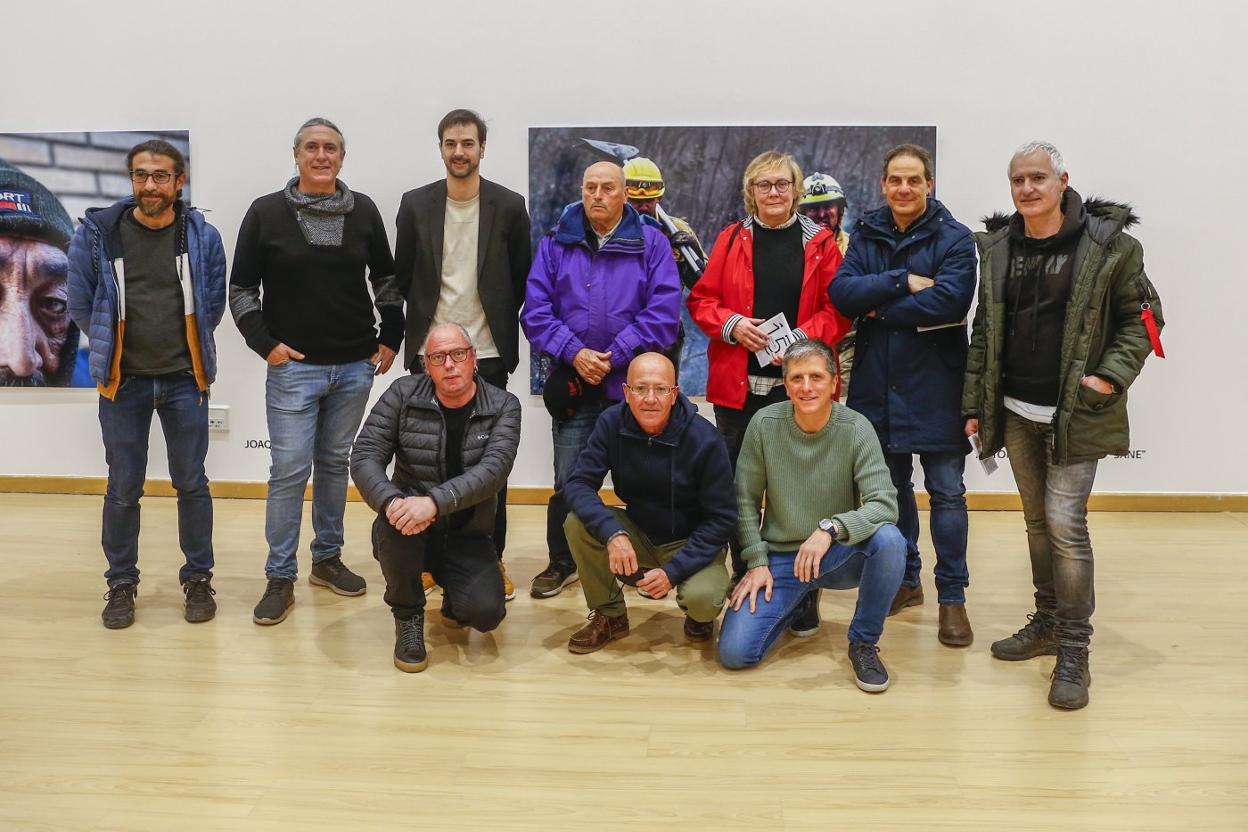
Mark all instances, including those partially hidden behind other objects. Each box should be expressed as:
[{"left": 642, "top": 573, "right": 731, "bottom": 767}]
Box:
[{"left": 719, "top": 524, "right": 906, "bottom": 670}]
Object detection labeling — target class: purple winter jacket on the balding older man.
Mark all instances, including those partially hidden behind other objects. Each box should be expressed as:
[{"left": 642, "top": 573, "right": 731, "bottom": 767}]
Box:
[{"left": 520, "top": 203, "right": 680, "bottom": 400}]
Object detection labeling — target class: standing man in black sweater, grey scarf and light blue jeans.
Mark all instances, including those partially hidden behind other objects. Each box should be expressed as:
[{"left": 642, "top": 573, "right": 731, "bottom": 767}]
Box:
[{"left": 230, "top": 119, "right": 403, "bottom": 625}]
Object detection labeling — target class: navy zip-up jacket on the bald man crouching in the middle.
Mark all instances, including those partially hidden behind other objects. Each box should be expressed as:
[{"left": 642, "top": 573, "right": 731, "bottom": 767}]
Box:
[{"left": 563, "top": 393, "right": 736, "bottom": 585}]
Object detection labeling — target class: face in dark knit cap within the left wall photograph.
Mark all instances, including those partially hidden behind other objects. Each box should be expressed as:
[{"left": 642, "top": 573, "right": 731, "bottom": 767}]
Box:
[{"left": 0, "top": 158, "right": 79, "bottom": 387}]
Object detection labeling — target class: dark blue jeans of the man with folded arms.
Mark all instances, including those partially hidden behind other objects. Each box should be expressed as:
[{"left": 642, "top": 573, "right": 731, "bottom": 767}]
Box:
[{"left": 884, "top": 452, "right": 971, "bottom": 604}]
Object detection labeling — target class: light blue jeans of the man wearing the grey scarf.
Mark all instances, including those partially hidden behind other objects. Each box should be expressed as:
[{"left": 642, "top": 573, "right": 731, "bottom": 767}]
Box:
[{"left": 265, "top": 360, "right": 373, "bottom": 580}]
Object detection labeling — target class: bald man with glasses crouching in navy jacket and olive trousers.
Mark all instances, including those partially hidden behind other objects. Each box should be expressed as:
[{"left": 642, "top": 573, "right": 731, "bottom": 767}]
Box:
[{"left": 563, "top": 353, "right": 736, "bottom": 654}]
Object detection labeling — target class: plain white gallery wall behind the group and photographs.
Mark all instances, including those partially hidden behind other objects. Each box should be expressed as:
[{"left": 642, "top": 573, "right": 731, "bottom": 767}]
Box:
[{"left": 0, "top": 0, "right": 1248, "bottom": 493}]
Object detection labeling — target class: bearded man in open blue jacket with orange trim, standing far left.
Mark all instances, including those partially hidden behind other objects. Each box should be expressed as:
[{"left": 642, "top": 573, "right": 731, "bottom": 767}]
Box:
[{"left": 69, "top": 140, "right": 226, "bottom": 630}]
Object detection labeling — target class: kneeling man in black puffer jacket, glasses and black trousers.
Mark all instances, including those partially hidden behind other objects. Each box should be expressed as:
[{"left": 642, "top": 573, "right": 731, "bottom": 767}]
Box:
[{"left": 351, "top": 323, "right": 520, "bottom": 674}]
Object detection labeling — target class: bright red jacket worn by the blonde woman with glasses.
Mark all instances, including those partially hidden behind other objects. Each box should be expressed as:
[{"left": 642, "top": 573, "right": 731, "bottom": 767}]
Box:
[{"left": 689, "top": 215, "right": 850, "bottom": 409}]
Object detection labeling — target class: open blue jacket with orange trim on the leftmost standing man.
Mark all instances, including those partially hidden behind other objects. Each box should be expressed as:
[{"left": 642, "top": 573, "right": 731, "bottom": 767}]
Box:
[{"left": 69, "top": 197, "right": 226, "bottom": 399}]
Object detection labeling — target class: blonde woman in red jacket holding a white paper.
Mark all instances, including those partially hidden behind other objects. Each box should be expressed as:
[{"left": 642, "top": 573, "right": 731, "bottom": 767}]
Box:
[{"left": 689, "top": 151, "right": 850, "bottom": 575}]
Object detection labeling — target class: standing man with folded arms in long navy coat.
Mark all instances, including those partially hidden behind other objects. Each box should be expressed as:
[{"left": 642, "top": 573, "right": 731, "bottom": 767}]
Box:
[{"left": 829, "top": 145, "right": 976, "bottom": 647}]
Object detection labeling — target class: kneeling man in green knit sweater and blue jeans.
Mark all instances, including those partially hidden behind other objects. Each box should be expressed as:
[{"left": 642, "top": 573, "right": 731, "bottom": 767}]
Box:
[{"left": 719, "top": 341, "right": 906, "bottom": 694}]
